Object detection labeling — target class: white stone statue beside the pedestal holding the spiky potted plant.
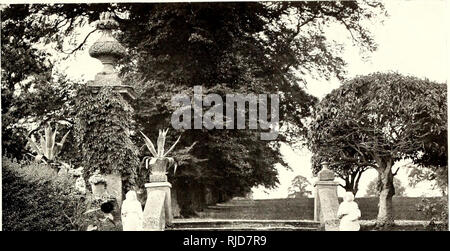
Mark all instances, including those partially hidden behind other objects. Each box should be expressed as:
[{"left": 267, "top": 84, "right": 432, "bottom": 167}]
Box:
[{"left": 121, "top": 191, "right": 144, "bottom": 231}]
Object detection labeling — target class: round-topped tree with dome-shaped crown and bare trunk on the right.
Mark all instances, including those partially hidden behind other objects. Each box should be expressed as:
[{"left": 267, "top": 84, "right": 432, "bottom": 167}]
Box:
[{"left": 309, "top": 73, "right": 447, "bottom": 226}]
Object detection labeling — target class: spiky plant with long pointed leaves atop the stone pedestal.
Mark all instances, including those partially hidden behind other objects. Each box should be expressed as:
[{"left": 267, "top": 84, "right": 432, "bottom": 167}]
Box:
[{"left": 141, "top": 128, "right": 181, "bottom": 173}]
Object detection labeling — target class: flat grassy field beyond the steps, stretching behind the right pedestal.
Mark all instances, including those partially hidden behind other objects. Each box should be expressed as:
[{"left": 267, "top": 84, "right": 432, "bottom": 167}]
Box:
[{"left": 200, "top": 197, "right": 442, "bottom": 220}]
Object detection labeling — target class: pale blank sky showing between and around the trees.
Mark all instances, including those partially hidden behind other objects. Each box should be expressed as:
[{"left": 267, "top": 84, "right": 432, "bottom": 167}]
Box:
[{"left": 51, "top": 0, "right": 450, "bottom": 199}]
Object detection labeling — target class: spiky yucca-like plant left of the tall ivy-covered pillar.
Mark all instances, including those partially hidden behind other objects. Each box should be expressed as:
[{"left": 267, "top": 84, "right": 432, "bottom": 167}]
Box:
[{"left": 28, "top": 124, "right": 70, "bottom": 163}]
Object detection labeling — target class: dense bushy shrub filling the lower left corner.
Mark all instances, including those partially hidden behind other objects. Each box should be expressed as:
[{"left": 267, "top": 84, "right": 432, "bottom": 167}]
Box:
[{"left": 2, "top": 158, "right": 87, "bottom": 231}]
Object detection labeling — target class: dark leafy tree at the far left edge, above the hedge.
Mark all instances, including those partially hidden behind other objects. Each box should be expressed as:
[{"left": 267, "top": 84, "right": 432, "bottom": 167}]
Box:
[{"left": 0, "top": 5, "right": 76, "bottom": 159}]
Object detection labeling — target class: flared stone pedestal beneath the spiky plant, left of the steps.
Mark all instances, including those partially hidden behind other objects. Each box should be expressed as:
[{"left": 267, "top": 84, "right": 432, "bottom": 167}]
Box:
[{"left": 143, "top": 182, "right": 173, "bottom": 231}]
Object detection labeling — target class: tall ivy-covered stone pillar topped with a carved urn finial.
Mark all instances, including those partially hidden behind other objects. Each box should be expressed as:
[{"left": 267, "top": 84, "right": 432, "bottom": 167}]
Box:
[{"left": 75, "top": 12, "right": 139, "bottom": 230}]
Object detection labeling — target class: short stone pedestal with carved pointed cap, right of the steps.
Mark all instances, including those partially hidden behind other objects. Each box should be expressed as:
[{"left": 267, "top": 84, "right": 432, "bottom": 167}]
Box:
[{"left": 314, "top": 164, "right": 339, "bottom": 231}]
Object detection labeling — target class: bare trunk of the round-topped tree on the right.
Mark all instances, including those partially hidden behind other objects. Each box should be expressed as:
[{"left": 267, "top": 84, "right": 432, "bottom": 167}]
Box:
[{"left": 376, "top": 160, "right": 395, "bottom": 228}]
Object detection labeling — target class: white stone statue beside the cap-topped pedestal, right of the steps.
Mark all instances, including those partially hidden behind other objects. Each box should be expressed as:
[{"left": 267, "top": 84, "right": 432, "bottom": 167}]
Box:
[{"left": 337, "top": 192, "right": 361, "bottom": 231}]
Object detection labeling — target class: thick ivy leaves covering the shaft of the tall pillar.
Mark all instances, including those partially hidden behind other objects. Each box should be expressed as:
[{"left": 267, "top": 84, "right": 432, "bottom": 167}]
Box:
[{"left": 74, "top": 87, "right": 139, "bottom": 191}]
